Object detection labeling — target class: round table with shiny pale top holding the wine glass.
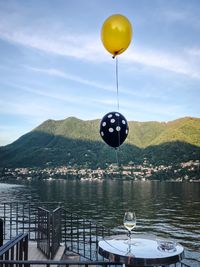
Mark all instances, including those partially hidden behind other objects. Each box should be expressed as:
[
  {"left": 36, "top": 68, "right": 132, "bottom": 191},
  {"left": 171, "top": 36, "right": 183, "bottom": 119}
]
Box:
[{"left": 99, "top": 236, "right": 184, "bottom": 266}]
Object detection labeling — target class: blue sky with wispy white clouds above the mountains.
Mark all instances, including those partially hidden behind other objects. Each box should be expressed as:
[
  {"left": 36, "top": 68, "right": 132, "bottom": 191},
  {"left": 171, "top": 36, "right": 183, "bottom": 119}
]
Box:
[{"left": 0, "top": 0, "right": 200, "bottom": 145}]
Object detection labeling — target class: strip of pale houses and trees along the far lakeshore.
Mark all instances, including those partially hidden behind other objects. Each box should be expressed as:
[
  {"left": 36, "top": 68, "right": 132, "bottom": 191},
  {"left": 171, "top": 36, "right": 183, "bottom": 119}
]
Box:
[{"left": 0, "top": 159, "right": 200, "bottom": 182}]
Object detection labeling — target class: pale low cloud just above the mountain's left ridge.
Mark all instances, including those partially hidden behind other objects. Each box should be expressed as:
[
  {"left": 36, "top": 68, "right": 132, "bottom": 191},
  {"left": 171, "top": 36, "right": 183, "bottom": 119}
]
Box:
[{"left": 0, "top": 83, "right": 112, "bottom": 121}]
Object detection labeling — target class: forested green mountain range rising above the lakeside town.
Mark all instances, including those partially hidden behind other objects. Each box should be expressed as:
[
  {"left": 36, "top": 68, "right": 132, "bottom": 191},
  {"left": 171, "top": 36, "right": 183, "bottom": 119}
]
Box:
[{"left": 0, "top": 117, "right": 200, "bottom": 168}]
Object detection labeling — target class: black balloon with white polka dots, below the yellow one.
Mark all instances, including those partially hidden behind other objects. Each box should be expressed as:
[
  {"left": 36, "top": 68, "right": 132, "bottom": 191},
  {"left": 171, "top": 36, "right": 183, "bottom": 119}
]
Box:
[{"left": 99, "top": 111, "right": 129, "bottom": 147}]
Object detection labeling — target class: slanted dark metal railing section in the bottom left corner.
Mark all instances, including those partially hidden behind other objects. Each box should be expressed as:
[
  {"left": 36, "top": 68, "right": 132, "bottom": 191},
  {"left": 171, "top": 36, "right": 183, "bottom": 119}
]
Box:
[{"left": 0, "top": 234, "right": 28, "bottom": 267}]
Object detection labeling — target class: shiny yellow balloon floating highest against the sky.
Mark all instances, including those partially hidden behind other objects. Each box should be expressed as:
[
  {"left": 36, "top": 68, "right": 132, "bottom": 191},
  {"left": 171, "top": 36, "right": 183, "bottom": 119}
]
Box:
[{"left": 101, "top": 14, "right": 132, "bottom": 57}]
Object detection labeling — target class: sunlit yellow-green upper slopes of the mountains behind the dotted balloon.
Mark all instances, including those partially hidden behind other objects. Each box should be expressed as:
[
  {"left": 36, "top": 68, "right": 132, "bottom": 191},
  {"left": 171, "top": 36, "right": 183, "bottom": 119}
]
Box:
[{"left": 33, "top": 117, "right": 200, "bottom": 147}]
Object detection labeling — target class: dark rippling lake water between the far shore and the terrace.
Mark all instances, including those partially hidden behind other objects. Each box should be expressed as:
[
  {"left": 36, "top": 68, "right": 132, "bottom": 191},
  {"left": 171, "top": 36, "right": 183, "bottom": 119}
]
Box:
[{"left": 0, "top": 180, "right": 200, "bottom": 261}]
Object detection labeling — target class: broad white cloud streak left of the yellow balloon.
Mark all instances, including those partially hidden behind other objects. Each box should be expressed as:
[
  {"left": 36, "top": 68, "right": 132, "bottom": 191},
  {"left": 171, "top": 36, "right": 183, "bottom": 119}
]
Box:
[{"left": 0, "top": 21, "right": 106, "bottom": 61}]
